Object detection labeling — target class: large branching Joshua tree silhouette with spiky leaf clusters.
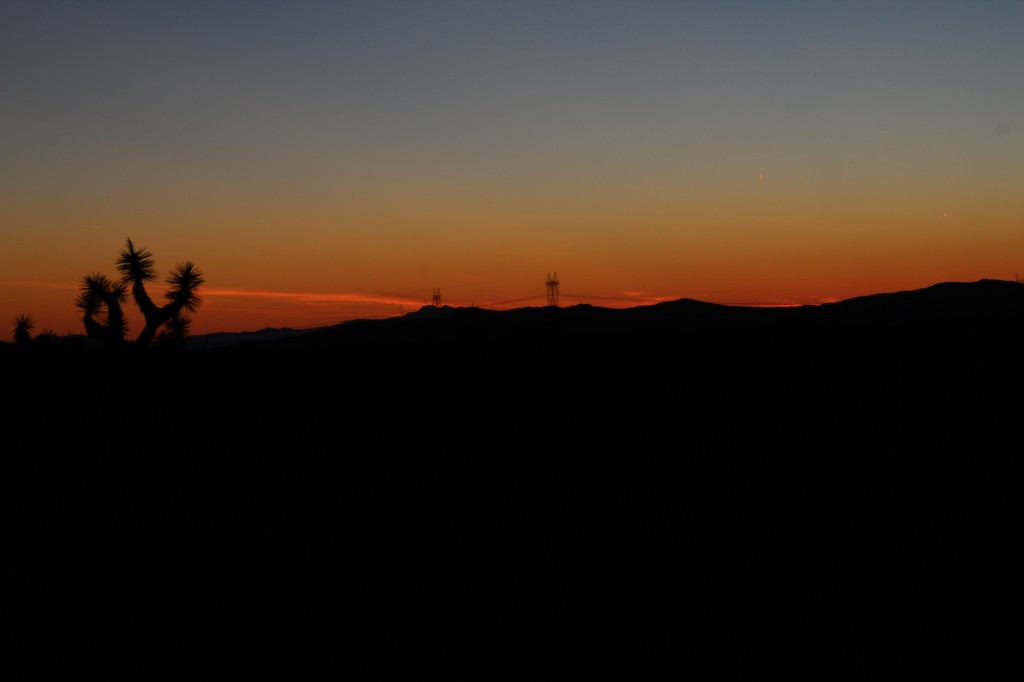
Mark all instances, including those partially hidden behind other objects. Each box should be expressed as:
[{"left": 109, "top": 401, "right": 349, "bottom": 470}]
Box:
[{"left": 75, "top": 239, "right": 204, "bottom": 346}]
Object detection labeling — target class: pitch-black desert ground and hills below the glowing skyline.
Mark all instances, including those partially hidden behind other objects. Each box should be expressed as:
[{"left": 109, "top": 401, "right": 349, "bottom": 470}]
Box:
[{"left": 0, "top": 281, "right": 1024, "bottom": 680}]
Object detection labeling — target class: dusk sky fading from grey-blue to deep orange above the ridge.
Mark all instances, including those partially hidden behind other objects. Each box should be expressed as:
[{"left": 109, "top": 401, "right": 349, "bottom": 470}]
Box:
[{"left": 0, "top": 0, "right": 1024, "bottom": 333}]
